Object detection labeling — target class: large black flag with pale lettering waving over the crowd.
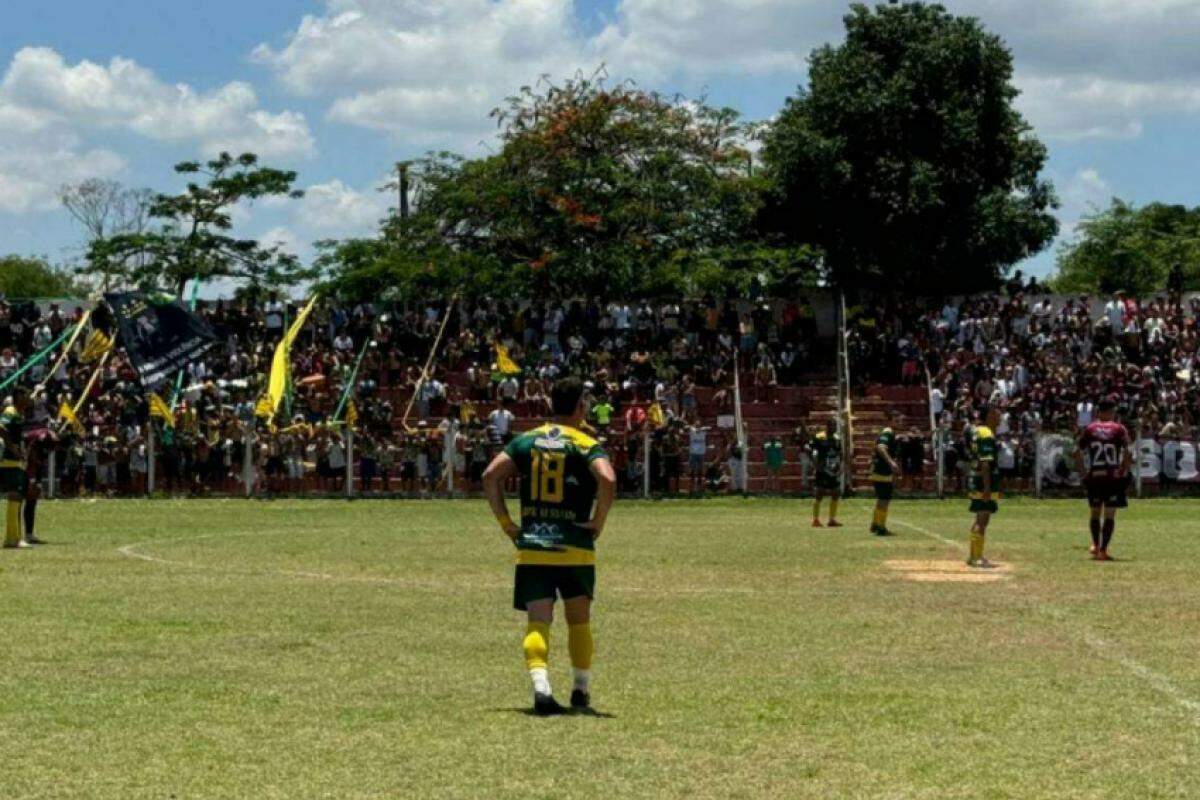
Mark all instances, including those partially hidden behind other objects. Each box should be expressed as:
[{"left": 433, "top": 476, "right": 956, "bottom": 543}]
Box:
[{"left": 104, "top": 291, "right": 217, "bottom": 389}]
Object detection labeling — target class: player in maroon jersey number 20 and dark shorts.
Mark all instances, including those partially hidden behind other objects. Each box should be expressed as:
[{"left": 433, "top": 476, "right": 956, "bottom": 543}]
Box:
[{"left": 1075, "top": 397, "right": 1133, "bottom": 561}]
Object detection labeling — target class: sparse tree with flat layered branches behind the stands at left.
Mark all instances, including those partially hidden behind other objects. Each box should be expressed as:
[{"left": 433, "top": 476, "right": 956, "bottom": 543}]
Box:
[{"left": 80, "top": 152, "right": 314, "bottom": 295}]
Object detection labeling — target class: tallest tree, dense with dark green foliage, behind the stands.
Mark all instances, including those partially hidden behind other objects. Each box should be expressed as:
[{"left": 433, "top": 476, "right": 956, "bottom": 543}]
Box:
[{"left": 762, "top": 2, "right": 1057, "bottom": 294}]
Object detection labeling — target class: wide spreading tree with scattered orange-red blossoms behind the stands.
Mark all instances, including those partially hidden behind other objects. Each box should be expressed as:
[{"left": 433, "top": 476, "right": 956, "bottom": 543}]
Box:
[{"left": 323, "top": 78, "right": 782, "bottom": 295}]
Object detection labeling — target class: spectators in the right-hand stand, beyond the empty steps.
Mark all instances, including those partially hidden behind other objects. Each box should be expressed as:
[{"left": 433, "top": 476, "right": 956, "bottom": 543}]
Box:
[{"left": 850, "top": 290, "right": 1200, "bottom": 482}]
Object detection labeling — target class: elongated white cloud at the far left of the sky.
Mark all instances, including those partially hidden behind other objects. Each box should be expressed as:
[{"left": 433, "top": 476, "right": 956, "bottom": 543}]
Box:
[{"left": 0, "top": 47, "right": 314, "bottom": 157}]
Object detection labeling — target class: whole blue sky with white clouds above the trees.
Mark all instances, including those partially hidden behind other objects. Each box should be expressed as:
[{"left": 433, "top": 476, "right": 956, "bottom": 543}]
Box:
[{"left": 0, "top": 0, "right": 1200, "bottom": 287}]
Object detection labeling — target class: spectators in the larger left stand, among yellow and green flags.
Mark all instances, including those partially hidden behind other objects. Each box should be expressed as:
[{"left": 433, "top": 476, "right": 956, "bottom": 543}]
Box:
[{"left": 0, "top": 297, "right": 816, "bottom": 495}]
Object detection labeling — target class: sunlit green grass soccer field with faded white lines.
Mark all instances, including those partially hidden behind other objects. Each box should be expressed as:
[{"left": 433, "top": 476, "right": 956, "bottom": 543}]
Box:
[{"left": 0, "top": 500, "right": 1200, "bottom": 800}]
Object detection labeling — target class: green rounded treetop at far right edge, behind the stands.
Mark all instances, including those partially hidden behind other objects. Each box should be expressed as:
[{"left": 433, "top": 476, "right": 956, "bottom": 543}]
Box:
[{"left": 1052, "top": 198, "right": 1200, "bottom": 295}]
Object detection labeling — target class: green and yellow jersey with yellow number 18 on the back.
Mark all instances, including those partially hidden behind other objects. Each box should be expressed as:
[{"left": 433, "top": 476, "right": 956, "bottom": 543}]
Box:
[{"left": 504, "top": 423, "right": 608, "bottom": 566}]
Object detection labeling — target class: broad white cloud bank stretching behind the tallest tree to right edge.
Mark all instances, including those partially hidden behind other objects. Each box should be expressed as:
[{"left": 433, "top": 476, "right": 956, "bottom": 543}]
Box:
[{"left": 254, "top": 0, "right": 1200, "bottom": 146}]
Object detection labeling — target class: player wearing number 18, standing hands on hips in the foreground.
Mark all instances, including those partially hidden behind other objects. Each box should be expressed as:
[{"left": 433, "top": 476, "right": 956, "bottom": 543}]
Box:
[{"left": 484, "top": 378, "right": 617, "bottom": 715}]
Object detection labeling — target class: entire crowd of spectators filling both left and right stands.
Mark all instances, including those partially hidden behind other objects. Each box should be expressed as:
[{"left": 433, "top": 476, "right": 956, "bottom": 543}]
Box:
[{"left": 9, "top": 289, "right": 1200, "bottom": 495}]
